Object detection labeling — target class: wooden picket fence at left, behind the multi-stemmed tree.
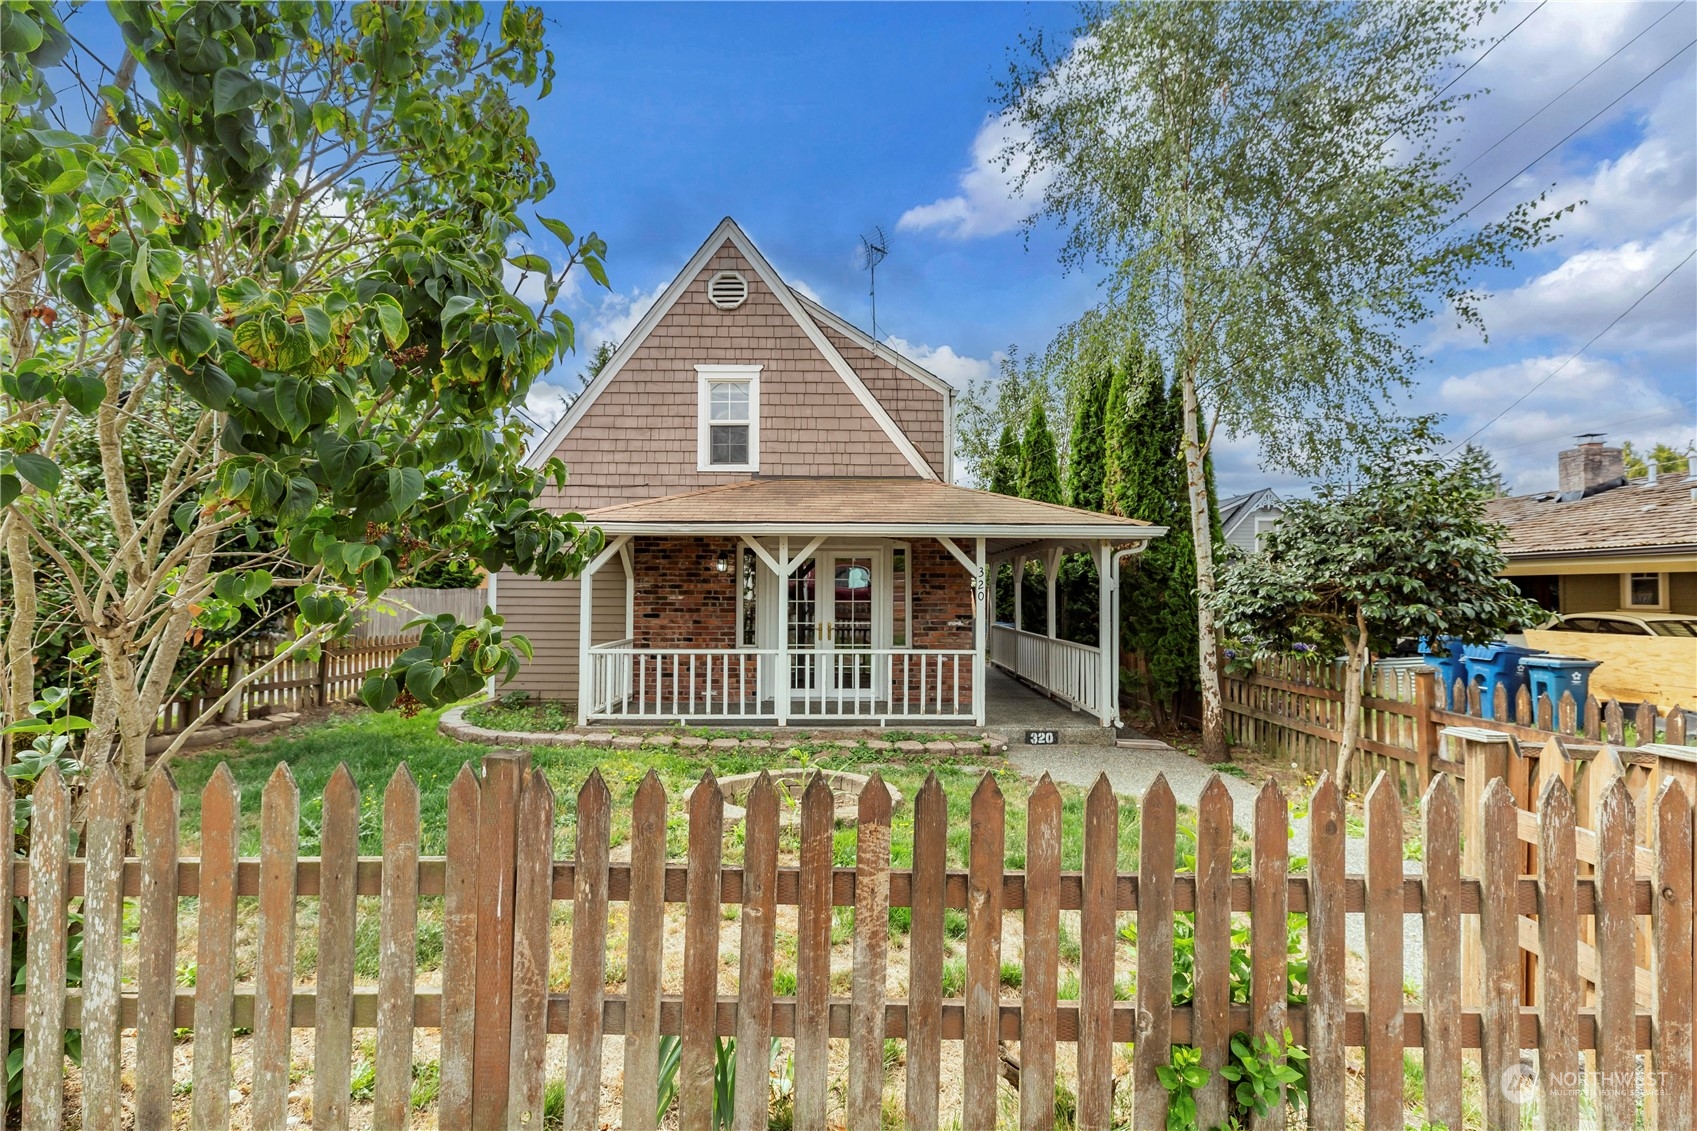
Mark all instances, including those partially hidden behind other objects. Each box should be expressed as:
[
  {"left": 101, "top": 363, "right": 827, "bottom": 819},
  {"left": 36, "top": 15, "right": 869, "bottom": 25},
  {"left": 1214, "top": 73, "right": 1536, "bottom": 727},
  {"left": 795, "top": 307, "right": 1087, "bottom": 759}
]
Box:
[{"left": 154, "top": 633, "right": 417, "bottom": 734}]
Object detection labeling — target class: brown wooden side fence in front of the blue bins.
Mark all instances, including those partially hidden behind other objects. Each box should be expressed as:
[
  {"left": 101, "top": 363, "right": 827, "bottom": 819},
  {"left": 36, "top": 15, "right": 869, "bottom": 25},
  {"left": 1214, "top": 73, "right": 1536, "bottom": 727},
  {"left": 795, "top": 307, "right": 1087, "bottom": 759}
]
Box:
[{"left": 1222, "top": 657, "right": 1697, "bottom": 798}]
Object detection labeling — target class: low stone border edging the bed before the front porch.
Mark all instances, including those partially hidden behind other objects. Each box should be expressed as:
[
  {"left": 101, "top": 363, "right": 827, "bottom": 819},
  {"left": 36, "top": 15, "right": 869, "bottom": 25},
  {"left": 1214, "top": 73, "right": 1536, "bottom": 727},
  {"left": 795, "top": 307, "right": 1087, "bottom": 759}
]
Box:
[{"left": 436, "top": 703, "right": 1008, "bottom": 757}]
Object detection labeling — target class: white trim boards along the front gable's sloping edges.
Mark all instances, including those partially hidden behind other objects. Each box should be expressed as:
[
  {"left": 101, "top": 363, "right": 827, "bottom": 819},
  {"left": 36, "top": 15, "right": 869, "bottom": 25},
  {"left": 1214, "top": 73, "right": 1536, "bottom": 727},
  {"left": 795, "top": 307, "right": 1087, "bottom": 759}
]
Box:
[{"left": 524, "top": 216, "right": 937, "bottom": 479}]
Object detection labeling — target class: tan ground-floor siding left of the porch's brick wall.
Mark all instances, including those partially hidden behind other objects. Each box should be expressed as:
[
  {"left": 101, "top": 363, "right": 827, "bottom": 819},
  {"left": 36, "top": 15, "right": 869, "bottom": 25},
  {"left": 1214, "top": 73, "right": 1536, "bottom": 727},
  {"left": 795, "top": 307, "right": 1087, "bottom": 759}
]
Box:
[{"left": 496, "top": 557, "right": 624, "bottom": 700}]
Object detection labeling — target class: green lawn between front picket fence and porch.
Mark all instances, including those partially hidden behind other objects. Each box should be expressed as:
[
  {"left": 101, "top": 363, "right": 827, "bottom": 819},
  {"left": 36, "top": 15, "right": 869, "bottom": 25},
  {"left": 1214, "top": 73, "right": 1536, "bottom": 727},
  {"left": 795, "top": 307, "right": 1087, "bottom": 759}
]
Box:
[{"left": 173, "top": 712, "right": 1247, "bottom": 869}]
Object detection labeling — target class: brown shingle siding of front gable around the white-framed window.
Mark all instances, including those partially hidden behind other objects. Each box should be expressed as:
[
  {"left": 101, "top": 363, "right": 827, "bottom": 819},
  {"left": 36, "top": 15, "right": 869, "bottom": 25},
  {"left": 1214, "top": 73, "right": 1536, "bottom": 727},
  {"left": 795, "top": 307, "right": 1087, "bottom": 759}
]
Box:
[{"left": 550, "top": 241, "right": 916, "bottom": 509}]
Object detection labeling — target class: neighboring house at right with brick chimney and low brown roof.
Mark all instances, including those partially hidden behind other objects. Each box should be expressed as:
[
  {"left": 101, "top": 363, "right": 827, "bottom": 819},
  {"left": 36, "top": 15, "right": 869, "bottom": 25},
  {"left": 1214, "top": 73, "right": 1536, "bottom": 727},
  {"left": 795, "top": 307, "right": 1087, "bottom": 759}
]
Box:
[{"left": 1485, "top": 436, "right": 1697, "bottom": 613}]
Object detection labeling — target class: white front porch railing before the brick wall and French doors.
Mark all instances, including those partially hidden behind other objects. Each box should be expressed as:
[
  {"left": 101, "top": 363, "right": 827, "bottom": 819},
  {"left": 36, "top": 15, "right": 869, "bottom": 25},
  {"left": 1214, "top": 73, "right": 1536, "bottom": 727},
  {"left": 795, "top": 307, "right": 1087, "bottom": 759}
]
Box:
[{"left": 584, "top": 640, "right": 974, "bottom": 723}]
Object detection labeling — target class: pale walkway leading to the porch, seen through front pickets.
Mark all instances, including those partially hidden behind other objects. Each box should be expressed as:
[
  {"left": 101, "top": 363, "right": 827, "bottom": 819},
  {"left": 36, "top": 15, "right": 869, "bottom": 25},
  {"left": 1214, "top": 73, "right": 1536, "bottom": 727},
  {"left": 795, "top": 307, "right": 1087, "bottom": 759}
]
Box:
[{"left": 1008, "top": 739, "right": 1425, "bottom": 987}]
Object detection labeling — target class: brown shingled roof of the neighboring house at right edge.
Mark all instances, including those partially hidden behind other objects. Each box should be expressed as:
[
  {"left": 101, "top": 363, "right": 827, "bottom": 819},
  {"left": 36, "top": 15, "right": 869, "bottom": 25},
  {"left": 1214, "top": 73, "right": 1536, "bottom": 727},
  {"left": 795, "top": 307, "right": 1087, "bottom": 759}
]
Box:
[{"left": 1485, "top": 475, "right": 1697, "bottom": 557}]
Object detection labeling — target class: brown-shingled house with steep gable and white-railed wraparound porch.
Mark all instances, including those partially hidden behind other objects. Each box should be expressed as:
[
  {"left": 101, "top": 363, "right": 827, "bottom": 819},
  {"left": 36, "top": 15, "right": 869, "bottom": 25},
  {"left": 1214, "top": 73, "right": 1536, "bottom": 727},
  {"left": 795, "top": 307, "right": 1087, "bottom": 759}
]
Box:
[{"left": 494, "top": 219, "right": 1164, "bottom": 725}]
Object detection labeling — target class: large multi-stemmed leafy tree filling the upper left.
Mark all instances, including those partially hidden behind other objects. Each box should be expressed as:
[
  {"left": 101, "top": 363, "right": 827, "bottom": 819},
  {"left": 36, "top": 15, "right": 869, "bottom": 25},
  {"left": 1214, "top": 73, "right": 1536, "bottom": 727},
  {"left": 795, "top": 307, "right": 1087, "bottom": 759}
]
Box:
[{"left": 0, "top": 0, "right": 606, "bottom": 786}]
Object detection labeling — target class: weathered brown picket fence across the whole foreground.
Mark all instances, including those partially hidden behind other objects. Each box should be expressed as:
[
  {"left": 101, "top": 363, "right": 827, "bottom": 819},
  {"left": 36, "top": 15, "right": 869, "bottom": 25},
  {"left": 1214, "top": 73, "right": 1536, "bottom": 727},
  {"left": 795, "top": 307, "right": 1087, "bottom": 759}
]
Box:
[{"left": 13, "top": 752, "right": 1694, "bottom": 1131}]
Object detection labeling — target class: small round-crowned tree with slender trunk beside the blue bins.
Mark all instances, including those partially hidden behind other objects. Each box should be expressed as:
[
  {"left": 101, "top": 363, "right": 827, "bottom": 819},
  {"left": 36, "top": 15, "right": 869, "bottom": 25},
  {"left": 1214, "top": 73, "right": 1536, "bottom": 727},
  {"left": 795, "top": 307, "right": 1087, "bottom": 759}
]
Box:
[{"left": 1208, "top": 423, "right": 1543, "bottom": 779}]
